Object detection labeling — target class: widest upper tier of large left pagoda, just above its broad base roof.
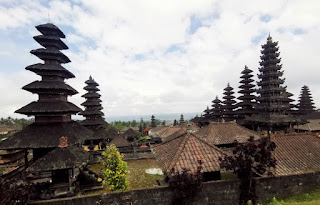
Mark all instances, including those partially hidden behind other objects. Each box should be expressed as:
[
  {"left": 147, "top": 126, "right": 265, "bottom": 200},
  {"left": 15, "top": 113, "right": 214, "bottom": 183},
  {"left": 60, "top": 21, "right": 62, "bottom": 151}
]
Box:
[{"left": 15, "top": 100, "right": 81, "bottom": 115}]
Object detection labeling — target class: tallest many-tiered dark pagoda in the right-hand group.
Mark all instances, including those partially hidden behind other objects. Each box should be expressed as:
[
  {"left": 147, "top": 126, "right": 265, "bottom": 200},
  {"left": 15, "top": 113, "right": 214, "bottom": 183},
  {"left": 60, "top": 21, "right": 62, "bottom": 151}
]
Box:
[{"left": 250, "top": 36, "right": 298, "bottom": 131}]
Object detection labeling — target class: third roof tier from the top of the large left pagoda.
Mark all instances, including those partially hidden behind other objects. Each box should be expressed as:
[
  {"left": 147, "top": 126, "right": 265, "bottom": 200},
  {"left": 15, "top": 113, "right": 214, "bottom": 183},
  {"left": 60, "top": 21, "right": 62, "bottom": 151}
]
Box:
[{"left": 30, "top": 48, "right": 71, "bottom": 63}]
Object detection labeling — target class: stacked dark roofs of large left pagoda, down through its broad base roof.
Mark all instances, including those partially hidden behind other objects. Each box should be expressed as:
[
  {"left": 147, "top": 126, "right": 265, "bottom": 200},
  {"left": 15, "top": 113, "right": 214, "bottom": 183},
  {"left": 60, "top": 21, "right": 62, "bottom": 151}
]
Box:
[{"left": 0, "top": 23, "right": 93, "bottom": 159}]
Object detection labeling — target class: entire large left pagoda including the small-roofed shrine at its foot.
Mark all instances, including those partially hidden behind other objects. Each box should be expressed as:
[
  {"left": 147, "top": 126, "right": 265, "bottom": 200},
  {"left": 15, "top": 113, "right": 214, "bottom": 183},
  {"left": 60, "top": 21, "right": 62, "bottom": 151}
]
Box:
[{"left": 0, "top": 23, "right": 92, "bottom": 198}]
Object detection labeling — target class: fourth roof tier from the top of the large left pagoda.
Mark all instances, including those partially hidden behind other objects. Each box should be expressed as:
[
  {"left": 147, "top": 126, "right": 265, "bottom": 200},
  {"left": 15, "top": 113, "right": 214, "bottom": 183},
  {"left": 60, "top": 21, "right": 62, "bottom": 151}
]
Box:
[{"left": 26, "top": 63, "right": 75, "bottom": 78}]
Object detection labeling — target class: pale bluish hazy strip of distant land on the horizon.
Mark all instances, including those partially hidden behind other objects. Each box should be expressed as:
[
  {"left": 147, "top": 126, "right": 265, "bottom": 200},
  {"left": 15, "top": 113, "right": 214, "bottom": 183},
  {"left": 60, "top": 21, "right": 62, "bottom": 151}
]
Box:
[{"left": 106, "top": 113, "right": 200, "bottom": 122}]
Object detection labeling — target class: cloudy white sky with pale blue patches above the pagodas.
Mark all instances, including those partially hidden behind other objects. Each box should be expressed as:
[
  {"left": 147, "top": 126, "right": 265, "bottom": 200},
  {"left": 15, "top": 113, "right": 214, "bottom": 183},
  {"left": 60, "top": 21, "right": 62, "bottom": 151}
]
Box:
[{"left": 0, "top": 0, "right": 320, "bottom": 117}]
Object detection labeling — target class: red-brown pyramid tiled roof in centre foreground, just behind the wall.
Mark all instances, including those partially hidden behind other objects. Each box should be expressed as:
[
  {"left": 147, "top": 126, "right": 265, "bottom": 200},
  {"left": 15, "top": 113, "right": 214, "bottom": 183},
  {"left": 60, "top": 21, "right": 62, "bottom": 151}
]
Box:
[{"left": 152, "top": 133, "right": 225, "bottom": 174}]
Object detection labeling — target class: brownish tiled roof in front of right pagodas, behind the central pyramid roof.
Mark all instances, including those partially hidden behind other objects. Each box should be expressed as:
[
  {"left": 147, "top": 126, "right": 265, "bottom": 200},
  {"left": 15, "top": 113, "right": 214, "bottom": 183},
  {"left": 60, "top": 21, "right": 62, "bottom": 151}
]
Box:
[{"left": 195, "top": 122, "right": 260, "bottom": 145}]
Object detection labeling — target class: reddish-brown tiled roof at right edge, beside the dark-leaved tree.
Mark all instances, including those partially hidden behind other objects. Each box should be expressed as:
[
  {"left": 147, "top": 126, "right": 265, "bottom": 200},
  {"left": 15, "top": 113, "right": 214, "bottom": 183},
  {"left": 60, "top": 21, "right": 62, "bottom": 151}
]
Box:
[{"left": 272, "top": 134, "right": 320, "bottom": 175}]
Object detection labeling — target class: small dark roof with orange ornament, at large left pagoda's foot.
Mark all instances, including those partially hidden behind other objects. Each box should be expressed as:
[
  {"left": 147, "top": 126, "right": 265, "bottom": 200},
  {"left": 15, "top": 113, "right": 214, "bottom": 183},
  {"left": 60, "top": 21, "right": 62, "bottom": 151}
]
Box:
[{"left": 27, "top": 146, "right": 89, "bottom": 172}]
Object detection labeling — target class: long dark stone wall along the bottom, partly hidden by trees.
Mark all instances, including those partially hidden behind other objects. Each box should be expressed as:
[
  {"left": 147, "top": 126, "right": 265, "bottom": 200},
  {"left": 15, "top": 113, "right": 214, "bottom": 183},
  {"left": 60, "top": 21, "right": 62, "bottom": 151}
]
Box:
[{"left": 30, "top": 173, "right": 320, "bottom": 205}]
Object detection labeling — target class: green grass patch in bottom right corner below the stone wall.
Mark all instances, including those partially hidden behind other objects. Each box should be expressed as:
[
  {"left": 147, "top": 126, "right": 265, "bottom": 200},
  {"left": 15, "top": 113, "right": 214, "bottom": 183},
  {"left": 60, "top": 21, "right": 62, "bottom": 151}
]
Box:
[{"left": 263, "top": 188, "right": 320, "bottom": 205}]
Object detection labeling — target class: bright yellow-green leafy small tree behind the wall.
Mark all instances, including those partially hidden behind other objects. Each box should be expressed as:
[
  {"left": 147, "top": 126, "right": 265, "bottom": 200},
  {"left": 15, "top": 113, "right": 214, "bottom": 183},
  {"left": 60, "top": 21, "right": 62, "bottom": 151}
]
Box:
[{"left": 102, "top": 144, "right": 129, "bottom": 191}]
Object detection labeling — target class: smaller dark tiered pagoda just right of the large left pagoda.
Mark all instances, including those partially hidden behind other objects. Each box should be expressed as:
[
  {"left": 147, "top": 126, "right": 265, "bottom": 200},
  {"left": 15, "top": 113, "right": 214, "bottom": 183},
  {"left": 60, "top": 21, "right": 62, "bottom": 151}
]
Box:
[{"left": 80, "top": 76, "right": 116, "bottom": 146}]
